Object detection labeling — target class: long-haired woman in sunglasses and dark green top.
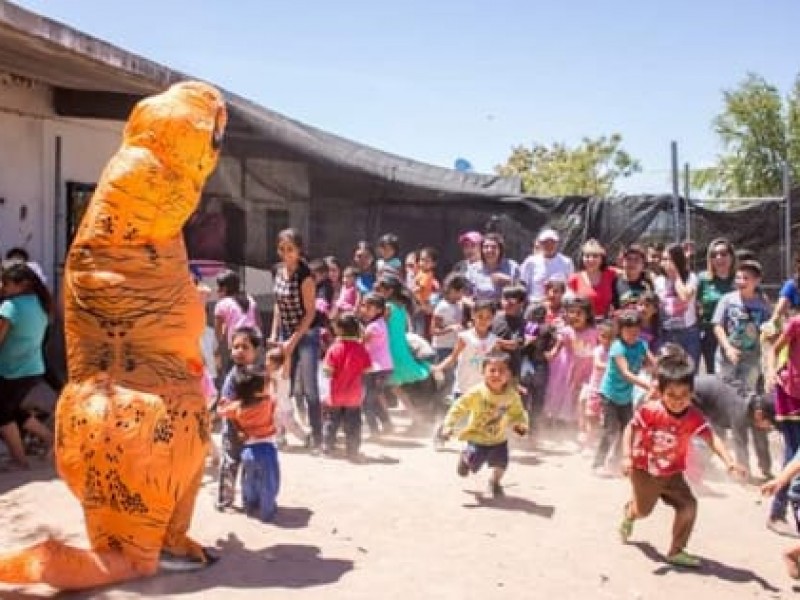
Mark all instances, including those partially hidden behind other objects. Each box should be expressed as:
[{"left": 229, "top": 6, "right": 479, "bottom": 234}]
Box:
[{"left": 697, "top": 238, "right": 736, "bottom": 374}]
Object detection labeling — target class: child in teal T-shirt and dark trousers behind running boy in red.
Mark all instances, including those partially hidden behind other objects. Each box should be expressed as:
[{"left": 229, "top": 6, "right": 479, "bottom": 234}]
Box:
[{"left": 592, "top": 310, "right": 655, "bottom": 476}]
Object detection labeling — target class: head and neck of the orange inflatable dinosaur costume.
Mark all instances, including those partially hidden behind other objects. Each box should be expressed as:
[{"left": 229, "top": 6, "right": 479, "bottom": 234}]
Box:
[{"left": 74, "top": 81, "right": 227, "bottom": 245}]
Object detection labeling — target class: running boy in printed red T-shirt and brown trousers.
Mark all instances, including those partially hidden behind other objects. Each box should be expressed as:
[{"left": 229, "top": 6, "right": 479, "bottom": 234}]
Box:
[{"left": 619, "top": 351, "right": 746, "bottom": 568}]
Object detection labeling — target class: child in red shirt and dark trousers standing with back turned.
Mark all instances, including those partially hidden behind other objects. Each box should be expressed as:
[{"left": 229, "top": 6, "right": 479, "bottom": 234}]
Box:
[{"left": 322, "top": 313, "right": 372, "bottom": 459}]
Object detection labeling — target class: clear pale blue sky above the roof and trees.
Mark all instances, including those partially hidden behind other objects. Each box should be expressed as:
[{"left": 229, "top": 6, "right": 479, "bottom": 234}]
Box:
[{"left": 17, "top": 0, "right": 800, "bottom": 193}]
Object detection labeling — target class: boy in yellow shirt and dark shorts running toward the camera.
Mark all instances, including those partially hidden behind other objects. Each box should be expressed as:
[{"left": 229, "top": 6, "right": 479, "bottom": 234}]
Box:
[{"left": 440, "top": 352, "right": 528, "bottom": 498}]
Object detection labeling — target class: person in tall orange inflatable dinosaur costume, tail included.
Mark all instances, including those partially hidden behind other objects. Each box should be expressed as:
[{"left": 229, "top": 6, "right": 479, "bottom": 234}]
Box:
[{"left": 0, "top": 82, "right": 227, "bottom": 589}]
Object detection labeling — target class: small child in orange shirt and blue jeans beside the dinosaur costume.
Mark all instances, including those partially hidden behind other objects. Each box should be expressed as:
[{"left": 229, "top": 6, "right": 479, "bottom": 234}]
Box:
[{"left": 217, "top": 367, "right": 280, "bottom": 522}]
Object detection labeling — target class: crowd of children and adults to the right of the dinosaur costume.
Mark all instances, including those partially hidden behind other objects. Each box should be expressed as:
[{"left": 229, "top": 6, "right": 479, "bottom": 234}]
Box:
[{"left": 10, "top": 229, "right": 800, "bottom": 577}]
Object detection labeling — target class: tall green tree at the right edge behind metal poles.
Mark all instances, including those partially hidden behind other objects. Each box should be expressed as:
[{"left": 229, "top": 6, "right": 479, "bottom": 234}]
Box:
[{"left": 692, "top": 73, "right": 800, "bottom": 198}]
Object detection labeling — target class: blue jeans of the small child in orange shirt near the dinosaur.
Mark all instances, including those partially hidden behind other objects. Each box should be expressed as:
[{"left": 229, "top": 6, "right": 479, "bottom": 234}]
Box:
[{"left": 242, "top": 442, "right": 281, "bottom": 522}]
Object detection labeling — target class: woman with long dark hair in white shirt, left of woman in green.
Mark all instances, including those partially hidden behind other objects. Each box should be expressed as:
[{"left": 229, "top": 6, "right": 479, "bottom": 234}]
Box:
[{"left": 655, "top": 244, "right": 700, "bottom": 368}]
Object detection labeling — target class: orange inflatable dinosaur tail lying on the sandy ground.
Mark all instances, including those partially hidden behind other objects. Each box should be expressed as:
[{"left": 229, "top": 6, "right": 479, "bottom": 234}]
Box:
[{"left": 0, "top": 539, "right": 147, "bottom": 590}]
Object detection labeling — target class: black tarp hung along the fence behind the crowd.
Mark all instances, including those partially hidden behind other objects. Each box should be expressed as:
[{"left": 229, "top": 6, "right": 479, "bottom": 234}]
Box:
[{"left": 190, "top": 186, "right": 800, "bottom": 283}]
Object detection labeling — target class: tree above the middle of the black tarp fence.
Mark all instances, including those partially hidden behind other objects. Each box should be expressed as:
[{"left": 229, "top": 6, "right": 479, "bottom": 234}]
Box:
[{"left": 495, "top": 133, "right": 641, "bottom": 197}]
